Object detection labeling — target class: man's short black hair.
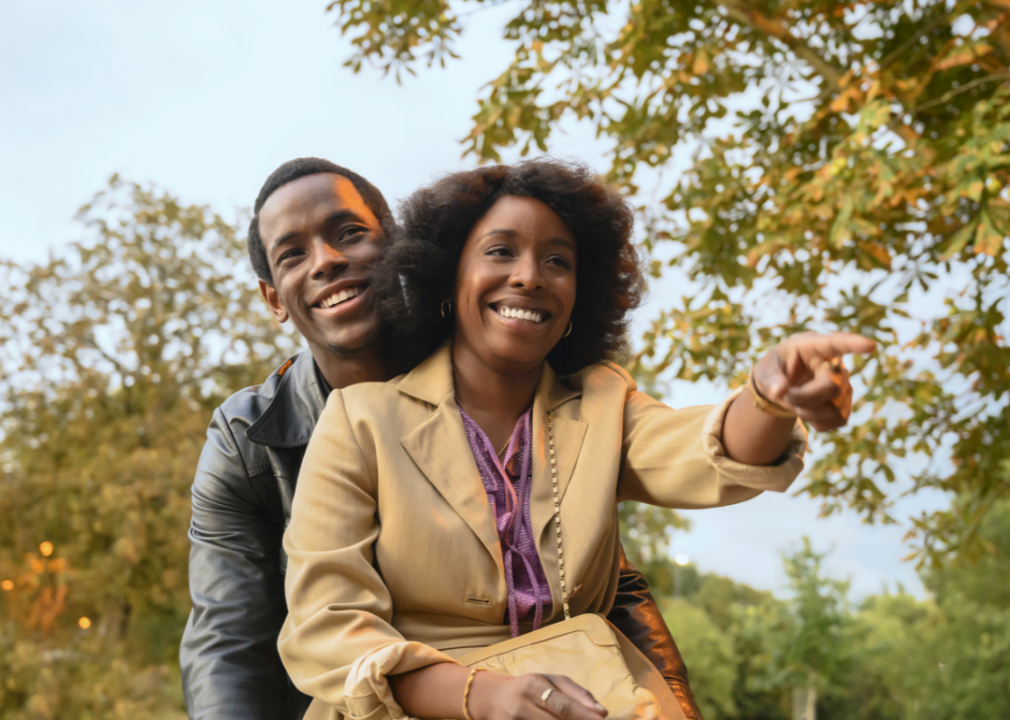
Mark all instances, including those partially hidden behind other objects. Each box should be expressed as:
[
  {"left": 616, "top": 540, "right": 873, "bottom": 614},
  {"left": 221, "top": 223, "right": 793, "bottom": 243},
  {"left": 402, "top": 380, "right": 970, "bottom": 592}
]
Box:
[{"left": 246, "top": 158, "right": 396, "bottom": 285}]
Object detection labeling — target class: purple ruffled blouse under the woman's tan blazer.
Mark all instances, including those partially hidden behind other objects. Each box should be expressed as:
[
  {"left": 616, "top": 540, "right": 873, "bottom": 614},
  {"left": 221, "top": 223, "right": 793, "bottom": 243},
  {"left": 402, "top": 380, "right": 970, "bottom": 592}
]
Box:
[{"left": 460, "top": 408, "right": 550, "bottom": 637}]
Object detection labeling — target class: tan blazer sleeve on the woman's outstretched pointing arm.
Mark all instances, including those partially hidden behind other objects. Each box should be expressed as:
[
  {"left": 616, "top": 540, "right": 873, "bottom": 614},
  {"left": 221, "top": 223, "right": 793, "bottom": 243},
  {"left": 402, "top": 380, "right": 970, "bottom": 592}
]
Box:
[{"left": 618, "top": 386, "right": 807, "bottom": 509}]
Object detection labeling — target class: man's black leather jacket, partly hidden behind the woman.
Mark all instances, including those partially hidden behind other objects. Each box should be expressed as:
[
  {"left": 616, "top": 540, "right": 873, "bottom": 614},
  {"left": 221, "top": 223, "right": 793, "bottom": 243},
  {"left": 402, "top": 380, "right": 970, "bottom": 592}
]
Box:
[{"left": 179, "top": 352, "right": 701, "bottom": 720}]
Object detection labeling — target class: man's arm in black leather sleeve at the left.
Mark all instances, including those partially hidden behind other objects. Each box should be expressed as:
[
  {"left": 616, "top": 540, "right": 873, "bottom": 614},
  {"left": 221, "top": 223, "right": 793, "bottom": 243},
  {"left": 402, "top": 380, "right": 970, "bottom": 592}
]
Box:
[{"left": 179, "top": 410, "right": 289, "bottom": 720}]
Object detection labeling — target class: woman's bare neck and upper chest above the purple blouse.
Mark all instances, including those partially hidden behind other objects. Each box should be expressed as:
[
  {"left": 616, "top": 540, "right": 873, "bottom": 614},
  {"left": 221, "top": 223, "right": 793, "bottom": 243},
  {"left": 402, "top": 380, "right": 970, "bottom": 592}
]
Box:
[{"left": 452, "top": 344, "right": 543, "bottom": 447}]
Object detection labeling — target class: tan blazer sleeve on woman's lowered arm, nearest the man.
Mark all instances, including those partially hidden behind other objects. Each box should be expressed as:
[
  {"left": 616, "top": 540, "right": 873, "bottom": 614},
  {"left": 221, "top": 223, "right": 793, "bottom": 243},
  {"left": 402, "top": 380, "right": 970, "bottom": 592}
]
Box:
[{"left": 279, "top": 391, "right": 456, "bottom": 720}]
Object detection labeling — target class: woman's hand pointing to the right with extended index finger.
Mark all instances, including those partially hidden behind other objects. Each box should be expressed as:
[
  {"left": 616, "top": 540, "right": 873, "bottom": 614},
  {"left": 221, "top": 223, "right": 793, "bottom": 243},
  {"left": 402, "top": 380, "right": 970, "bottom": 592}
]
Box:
[{"left": 753, "top": 332, "right": 877, "bottom": 432}]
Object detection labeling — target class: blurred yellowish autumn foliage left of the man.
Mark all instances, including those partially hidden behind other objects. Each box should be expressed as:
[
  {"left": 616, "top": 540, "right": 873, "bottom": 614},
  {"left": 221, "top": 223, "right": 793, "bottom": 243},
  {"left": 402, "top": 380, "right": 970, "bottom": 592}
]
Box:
[{"left": 0, "top": 178, "right": 294, "bottom": 720}]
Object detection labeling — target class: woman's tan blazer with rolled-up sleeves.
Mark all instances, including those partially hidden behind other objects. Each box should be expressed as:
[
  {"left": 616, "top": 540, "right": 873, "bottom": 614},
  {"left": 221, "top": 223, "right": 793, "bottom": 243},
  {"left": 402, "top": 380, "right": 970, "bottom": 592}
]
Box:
[{"left": 279, "top": 347, "right": 805, "bottom": 720}]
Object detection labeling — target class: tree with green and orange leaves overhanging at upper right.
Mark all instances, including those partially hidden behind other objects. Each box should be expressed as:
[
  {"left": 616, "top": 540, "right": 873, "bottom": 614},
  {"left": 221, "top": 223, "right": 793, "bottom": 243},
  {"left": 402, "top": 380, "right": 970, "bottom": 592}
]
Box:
[{"left": 329, "top": 0, "right": 1010, "bottom": 561}]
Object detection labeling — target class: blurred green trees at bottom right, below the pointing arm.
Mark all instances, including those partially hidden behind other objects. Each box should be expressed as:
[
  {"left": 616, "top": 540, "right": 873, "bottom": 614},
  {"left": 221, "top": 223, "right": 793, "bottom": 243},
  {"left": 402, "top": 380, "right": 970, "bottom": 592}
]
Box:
[{"left": 661, "top": 501, "right": 1010, "bottom": 720}]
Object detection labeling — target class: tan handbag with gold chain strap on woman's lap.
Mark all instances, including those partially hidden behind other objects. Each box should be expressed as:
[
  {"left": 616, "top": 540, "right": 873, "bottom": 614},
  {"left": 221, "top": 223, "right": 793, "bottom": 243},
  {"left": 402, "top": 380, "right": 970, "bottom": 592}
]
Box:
[{"left": 457, "top": 412, "right": 687, "bottom": 720}]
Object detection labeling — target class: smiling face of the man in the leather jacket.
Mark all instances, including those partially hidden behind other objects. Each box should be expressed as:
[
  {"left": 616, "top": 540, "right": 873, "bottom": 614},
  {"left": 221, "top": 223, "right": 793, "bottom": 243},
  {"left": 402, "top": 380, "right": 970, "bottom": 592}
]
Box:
[{"left": 260, "top": 173, "right": 385, "bottom": 354}]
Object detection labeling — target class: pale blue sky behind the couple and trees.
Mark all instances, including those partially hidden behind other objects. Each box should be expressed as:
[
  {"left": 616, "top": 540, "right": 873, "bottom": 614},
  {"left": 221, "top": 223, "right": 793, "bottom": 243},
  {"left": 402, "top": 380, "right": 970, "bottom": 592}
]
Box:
[{"left": 0, "top": 0, "right": 938, "bottom": 599}]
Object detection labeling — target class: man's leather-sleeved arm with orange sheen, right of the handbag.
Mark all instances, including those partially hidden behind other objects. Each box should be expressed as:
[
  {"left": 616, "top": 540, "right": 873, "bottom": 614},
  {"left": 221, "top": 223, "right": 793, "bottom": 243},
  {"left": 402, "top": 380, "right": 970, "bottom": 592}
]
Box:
[{"left": 607, "top": 547, "right": 702, "bottom": 720}]
